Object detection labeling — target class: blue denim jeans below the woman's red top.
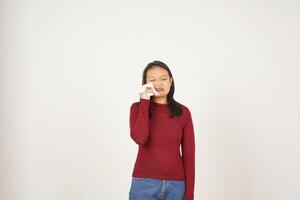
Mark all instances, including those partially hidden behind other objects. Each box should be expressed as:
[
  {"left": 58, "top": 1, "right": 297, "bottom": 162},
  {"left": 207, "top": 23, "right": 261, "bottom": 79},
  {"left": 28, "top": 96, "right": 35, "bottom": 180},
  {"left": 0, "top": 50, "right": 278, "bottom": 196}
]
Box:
[{"left": 129, "top": 177, "right": 185, "bottom": 200}]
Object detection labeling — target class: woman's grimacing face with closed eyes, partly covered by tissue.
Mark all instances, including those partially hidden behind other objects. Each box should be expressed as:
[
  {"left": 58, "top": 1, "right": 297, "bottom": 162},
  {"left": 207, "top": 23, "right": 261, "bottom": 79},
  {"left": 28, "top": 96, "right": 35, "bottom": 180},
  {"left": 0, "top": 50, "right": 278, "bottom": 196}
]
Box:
[{"left": 146, "top": 66, "right": 172, "bottom": 96}]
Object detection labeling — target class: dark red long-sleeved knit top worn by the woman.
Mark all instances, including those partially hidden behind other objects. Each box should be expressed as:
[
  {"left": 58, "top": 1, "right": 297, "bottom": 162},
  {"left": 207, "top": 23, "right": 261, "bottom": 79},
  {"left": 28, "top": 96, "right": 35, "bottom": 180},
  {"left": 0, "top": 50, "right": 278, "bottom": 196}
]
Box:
[{"left": 130, "top": 98, "right": 195, "bottom": 200}]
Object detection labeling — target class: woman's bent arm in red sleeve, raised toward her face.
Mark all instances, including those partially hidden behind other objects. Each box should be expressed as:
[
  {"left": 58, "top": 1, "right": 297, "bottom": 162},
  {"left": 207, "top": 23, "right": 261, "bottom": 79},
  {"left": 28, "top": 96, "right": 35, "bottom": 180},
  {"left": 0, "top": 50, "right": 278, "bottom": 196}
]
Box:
[{"left": 130, "top": 98, "right": 150, "bottom": 145}]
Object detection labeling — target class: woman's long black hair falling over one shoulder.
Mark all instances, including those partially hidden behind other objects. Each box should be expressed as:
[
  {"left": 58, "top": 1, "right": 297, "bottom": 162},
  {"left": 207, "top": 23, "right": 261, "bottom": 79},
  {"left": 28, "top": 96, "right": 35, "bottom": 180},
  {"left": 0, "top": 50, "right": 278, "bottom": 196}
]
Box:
[{"left": 142, "top": 60, "right": 183, "bottom": 118}]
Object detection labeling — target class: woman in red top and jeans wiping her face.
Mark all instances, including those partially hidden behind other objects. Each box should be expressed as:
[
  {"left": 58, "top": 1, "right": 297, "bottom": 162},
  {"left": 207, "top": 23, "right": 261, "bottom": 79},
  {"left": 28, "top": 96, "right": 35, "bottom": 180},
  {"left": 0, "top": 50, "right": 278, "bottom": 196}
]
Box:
[{"left": 129, "top": 61, "right": 195, "bottom": 200}]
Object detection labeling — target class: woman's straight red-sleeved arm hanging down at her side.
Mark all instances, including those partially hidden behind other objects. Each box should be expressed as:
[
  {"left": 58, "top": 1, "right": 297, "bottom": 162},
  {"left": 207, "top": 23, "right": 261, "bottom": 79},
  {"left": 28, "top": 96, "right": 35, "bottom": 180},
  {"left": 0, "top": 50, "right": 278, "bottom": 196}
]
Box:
[{"left": 181, "top": 109, "right": 195, "bottom": 200}]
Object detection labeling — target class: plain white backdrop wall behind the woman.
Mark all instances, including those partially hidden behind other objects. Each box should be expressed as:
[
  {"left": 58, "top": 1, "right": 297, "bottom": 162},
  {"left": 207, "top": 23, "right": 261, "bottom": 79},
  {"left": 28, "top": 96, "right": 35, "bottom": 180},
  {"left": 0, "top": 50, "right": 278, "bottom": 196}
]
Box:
[{"left": 0, "top": 0, "right": 300, "bottom": 200}]
